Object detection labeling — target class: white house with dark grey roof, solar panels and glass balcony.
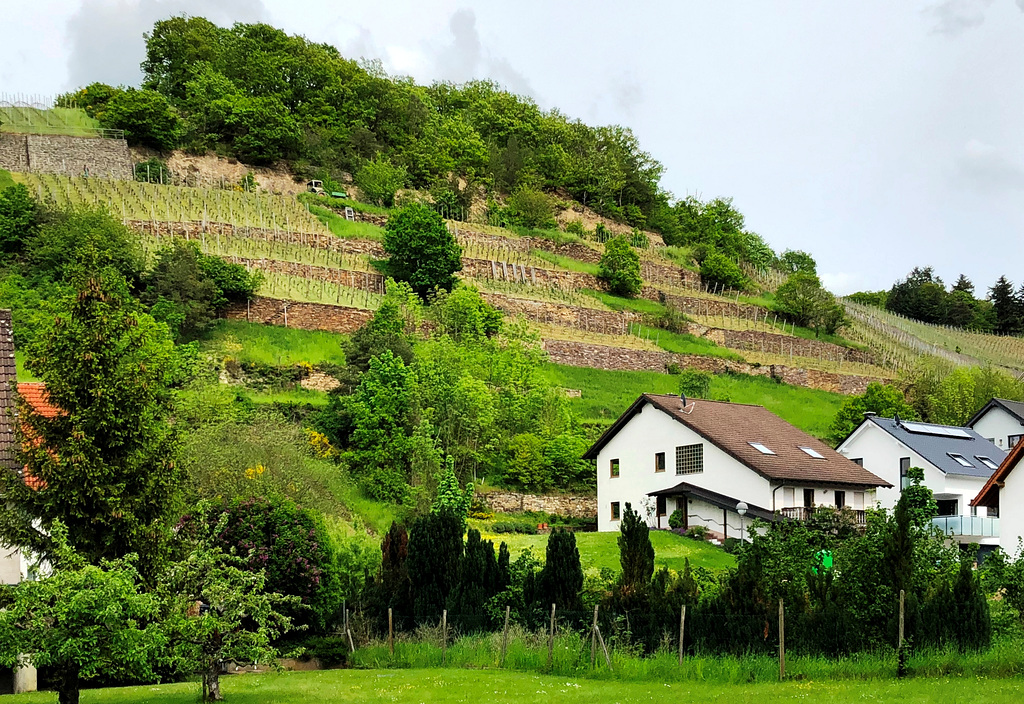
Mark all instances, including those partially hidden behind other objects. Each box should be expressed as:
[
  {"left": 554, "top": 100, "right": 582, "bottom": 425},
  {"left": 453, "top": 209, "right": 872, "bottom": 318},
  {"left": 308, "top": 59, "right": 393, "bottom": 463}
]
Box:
[{"left": 837, "top": 414, "right": 1007, "bottom": 545}]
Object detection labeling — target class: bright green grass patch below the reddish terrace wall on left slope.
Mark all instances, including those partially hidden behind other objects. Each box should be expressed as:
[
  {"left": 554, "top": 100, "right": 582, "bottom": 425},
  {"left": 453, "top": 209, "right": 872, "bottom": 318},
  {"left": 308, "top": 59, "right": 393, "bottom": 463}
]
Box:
[{"left": 200, "top": 320, "right": 346, "bottom": 365}]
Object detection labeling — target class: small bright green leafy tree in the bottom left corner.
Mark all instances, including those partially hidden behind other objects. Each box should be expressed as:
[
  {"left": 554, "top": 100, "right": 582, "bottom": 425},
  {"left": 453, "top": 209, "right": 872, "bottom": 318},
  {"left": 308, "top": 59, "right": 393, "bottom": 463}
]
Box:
[{"left": 0, "top": 522, "right": 166, "bottom": 704}]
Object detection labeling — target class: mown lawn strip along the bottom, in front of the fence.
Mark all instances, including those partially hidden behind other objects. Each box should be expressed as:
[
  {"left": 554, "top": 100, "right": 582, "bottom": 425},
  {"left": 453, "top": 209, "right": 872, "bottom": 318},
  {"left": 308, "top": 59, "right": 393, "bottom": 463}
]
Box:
[{"left": 0, "top": 669, "right": 1024, "bottom": 704}]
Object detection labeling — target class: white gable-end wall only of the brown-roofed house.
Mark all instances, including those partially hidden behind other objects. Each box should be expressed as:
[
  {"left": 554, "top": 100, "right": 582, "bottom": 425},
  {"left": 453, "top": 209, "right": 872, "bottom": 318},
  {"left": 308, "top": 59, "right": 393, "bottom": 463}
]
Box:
[{"left": 597, "top": 404, "right": 771, "bottom": 535}]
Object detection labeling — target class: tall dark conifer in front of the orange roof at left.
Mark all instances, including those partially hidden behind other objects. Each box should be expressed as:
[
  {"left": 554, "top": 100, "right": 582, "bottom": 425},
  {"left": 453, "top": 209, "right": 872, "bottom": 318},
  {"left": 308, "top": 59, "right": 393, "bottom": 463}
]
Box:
[{"left": 0, "top": 269, "right": 181, "bottom": 573}]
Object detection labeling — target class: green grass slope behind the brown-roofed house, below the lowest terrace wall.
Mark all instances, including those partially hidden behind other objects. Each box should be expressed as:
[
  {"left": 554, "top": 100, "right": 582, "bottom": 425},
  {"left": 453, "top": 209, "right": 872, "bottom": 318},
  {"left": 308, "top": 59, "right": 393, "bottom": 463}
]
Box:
[{"left": 543, "top": 364, "right": 846, "bottom": 438}]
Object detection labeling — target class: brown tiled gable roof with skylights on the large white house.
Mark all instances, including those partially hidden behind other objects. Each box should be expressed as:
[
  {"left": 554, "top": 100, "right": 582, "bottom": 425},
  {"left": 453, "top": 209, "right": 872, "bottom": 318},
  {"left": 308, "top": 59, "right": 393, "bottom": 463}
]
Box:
[{"left": 584, "top": 394, "right": 892, "bottom": 487}]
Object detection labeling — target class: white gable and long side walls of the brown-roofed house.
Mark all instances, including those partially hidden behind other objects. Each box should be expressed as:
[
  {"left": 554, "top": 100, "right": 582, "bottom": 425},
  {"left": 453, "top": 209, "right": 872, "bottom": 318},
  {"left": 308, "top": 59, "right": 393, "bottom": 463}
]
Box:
[{"left": 597, "top": 403, "right": 874, "bottom": 537}]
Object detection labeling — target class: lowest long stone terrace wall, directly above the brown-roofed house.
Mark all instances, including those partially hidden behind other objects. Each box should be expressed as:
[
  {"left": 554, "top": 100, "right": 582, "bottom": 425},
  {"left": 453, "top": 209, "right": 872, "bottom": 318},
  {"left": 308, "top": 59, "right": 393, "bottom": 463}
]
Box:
[{"left": 544, "top": 340, "right": 885, "bottom": 394}]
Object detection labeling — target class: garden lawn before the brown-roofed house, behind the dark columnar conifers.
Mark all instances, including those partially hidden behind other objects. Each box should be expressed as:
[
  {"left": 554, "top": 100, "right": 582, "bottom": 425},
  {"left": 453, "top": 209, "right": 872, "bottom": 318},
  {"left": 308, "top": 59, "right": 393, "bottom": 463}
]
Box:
[{"left": 470, "top": 521, "right": 736, "bottom": 572}]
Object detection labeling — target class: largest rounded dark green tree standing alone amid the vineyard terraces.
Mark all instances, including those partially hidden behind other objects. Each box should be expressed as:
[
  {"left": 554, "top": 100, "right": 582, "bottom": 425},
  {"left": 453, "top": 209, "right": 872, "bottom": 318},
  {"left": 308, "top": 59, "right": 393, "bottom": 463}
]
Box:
[{"left": 384, "top": 204, "right": 462, "bottom": 297}]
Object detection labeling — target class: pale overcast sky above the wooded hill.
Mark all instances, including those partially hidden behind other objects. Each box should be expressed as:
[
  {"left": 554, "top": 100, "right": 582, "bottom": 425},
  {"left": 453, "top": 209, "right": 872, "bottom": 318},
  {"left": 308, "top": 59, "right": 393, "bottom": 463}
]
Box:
[{"left": 0, "top": 0, "right": 1024, "bottom": 294}]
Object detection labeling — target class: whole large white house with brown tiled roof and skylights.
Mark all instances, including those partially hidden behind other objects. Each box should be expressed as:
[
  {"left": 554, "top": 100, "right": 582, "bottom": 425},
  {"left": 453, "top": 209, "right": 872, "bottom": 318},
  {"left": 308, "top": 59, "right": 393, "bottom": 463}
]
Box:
[{"left": 584, "top": 394, "right": 889, "bottom": 537}]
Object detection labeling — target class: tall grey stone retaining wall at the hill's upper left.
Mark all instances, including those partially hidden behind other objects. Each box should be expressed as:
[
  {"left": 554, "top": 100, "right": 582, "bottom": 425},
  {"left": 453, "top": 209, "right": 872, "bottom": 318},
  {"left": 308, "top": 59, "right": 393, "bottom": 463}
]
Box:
[{"left": 0, "top": 133, "right": 133, "bottom": 181}]
